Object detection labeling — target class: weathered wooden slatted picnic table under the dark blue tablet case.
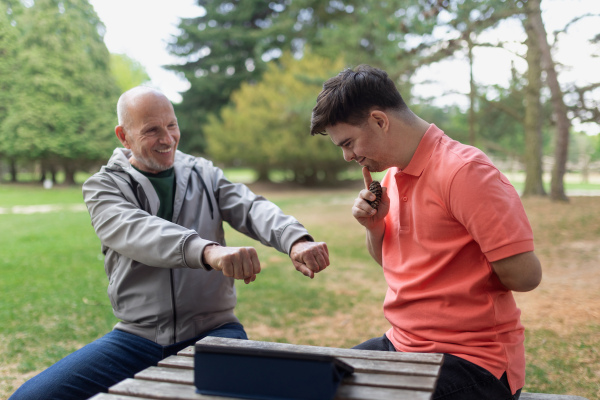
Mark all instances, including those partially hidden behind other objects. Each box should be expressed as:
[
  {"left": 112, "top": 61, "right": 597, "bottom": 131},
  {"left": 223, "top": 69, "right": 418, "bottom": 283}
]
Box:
[{"left": 90, "top": 337, "right": 443, "bottom": 400}]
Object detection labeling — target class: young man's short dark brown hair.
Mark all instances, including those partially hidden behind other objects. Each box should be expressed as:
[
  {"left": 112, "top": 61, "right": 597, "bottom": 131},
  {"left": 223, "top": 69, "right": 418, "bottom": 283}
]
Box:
[{"left": 310, "top": 65, "right": 407, "bottom": 136}]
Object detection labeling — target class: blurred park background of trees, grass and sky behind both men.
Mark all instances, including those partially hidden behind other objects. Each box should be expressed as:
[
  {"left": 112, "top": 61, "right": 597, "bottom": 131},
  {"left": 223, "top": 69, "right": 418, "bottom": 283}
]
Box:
[{"left": 0, "top": 0, "right": 600, "bottom": 399}]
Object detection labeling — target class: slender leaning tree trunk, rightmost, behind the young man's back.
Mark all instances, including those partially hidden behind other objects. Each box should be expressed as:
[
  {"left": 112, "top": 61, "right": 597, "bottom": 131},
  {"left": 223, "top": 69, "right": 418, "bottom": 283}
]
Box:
[{"left": 527, "top": 0, "right": 571, "bottom": 201}]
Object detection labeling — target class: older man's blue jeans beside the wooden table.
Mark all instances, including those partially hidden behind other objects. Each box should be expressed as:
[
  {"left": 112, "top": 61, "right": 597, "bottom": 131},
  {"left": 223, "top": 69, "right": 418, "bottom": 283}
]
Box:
[{"left": 9, "top": 323, "right": 248, "bottom": 400}]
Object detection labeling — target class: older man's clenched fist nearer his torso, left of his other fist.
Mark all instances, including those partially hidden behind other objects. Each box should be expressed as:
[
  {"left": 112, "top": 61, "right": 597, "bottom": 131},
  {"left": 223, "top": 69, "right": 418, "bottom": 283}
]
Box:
[{"left": 203, "top": 245, "right": 260, "bottom": 283}]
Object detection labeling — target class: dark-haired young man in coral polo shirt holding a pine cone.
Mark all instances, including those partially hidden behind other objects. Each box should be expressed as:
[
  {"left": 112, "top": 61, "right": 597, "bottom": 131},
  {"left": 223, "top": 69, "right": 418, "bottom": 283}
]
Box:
[{"left": 311, "top": 66, "right": 541, "bottom": 400}]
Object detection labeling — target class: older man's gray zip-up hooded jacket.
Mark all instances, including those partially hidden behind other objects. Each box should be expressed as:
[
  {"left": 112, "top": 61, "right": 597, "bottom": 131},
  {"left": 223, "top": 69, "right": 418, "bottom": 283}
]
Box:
[{"left": 83, "top": 148, "right": 312, "bottom": 346}]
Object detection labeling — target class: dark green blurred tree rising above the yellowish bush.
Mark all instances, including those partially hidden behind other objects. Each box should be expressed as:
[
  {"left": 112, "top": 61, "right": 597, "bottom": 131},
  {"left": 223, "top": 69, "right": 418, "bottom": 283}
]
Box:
[{"left": 170, "top": 0, "right": 508, "bottom": 152}]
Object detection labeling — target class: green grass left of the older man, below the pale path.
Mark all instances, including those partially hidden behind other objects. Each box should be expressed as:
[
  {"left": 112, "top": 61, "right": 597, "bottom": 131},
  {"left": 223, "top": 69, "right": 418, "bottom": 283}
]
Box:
[{"left": 0, "top": 212, "right": 115, "bottom": 372}]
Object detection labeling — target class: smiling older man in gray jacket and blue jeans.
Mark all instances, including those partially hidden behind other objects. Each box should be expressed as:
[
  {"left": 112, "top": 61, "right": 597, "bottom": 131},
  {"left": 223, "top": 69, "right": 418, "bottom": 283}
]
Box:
[{"left": 11, "top": 87, "right": 329, "bottom": 399}]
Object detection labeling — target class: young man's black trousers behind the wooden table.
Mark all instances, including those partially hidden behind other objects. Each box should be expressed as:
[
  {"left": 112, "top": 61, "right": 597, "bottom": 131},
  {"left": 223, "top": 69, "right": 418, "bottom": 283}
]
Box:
[{"left": 353, "top": 335, "right": 521, "bottom": 400}]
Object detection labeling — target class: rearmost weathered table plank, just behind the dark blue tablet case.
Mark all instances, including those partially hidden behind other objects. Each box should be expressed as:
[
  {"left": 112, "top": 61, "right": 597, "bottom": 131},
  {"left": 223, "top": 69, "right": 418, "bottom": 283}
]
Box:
[{"left": 178, "top": 336, "right": 443, "bottom": 365}]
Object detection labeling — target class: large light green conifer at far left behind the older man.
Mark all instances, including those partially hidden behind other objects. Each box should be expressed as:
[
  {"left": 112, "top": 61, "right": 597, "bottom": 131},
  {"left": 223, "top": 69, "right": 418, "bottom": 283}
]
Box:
[{"left": 0, "top": 0, "right": 119, "bottom": 181}]
